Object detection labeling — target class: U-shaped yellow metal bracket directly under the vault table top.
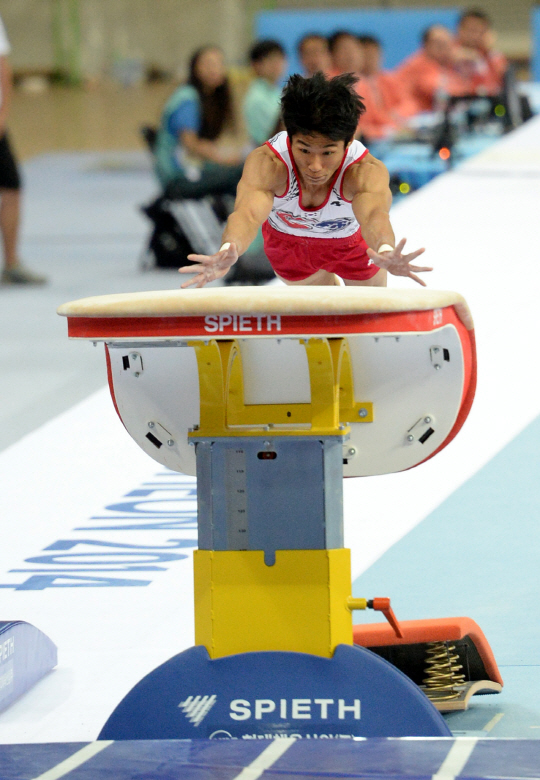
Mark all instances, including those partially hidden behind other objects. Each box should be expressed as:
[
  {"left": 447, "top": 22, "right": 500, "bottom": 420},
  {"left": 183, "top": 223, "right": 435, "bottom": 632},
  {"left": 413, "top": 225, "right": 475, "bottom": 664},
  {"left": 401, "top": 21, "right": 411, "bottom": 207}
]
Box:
[{"left": 188, "top": 338, "right": 373, "bottom": 437}]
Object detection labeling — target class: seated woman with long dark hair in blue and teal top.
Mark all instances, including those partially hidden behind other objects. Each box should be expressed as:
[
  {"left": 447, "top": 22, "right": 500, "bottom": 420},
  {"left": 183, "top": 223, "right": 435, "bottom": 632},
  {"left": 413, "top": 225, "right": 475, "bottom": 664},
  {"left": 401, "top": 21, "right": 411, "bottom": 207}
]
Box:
[{"left": 155, "top": 46, "right": 243, "bottom": 198}]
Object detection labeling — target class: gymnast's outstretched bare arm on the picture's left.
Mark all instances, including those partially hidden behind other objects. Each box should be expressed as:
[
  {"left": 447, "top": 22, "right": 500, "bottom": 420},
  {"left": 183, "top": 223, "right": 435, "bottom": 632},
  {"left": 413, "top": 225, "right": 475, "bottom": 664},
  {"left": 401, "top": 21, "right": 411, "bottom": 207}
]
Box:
[{"left": 179, "top": 146, "right": 287, "bottom": 287}]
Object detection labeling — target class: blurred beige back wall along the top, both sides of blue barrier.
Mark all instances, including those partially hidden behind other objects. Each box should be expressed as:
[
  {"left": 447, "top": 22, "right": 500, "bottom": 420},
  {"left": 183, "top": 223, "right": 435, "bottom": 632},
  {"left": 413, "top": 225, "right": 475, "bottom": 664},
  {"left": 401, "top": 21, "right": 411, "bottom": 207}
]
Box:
[{"left": 0, "top": 0, "right": 532, "bottom": 77}]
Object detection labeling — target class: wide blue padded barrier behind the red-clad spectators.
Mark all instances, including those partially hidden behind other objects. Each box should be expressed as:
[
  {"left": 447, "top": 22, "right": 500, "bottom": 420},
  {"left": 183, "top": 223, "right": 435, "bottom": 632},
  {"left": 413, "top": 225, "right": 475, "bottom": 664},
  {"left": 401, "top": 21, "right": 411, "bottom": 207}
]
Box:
[{"left": 255, "top": 8, "right": 461, "bottom": 73}]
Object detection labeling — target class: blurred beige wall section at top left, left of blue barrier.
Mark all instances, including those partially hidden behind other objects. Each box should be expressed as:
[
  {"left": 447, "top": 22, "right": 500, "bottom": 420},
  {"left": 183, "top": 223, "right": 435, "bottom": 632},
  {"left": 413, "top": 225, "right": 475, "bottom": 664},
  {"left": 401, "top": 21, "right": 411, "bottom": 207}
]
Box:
[{"left": 0, "top": 0, "right": 262, "bottom": 77}]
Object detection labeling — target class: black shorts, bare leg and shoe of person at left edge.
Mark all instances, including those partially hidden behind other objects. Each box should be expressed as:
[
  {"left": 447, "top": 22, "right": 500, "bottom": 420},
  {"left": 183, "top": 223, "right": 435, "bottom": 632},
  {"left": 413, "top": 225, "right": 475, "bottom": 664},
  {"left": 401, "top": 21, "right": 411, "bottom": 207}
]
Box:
[{"left": 0, "top": 133, "right": 47, "bottom": 284}]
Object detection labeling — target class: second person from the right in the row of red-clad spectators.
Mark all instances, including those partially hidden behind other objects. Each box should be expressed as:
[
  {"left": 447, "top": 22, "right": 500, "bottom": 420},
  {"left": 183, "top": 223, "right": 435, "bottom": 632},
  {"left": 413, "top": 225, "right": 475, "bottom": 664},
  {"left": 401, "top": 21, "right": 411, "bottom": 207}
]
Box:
[{"left": 395, "top": 24, "right": 470, "bottom": 112}]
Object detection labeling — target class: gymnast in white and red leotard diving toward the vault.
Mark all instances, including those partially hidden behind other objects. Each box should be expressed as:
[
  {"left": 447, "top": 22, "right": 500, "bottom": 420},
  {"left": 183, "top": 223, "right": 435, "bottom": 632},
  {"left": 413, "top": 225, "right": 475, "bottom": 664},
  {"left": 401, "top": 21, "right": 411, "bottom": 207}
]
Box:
[{"left": 179, "top": 73, "right": 432, "bottom": 287}]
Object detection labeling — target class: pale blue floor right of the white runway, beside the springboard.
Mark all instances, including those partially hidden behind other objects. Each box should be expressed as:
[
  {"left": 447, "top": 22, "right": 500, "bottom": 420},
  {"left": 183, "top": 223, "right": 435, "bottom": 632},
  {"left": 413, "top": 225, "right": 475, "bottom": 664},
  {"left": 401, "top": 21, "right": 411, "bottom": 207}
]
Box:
[{"left": 353, "top": 418, "right": 540, "bottom": 736}]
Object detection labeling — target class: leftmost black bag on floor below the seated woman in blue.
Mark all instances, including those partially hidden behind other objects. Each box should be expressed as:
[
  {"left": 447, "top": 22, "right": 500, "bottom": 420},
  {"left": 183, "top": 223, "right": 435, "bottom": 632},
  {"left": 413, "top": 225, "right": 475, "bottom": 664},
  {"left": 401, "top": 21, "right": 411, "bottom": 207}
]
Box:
[{"left": 141, "top": 197, "right": 194, "bottom": 268}]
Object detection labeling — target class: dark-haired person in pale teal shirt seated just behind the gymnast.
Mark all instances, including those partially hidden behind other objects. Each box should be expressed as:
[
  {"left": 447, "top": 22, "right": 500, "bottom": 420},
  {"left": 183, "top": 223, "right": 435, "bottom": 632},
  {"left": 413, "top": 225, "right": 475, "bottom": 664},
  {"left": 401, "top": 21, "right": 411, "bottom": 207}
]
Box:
[{"left": 244, "top": 40, "right": 287, "bottom": 146}]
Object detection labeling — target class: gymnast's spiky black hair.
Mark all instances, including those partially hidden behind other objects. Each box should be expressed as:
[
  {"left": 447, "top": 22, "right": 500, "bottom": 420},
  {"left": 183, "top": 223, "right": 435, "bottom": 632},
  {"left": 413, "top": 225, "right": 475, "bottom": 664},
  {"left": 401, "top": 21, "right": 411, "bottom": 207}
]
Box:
[{"left": 281, "top": 73, "right": 366, "bottom": 144}]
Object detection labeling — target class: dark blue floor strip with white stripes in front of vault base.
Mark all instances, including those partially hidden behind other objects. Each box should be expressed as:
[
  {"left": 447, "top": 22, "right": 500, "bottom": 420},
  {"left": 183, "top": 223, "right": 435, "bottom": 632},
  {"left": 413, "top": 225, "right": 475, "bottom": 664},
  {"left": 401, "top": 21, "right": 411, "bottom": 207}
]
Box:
[{"left": 0, "top": 739, "right": 540, "bottom": 780}]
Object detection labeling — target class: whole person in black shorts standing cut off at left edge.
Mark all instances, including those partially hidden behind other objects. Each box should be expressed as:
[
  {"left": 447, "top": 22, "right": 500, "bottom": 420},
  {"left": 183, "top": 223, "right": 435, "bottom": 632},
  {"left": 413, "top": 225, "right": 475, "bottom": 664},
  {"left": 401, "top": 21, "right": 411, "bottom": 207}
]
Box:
[{"left": 0, "top": 13, "right": 46, "bottom": 284}]
